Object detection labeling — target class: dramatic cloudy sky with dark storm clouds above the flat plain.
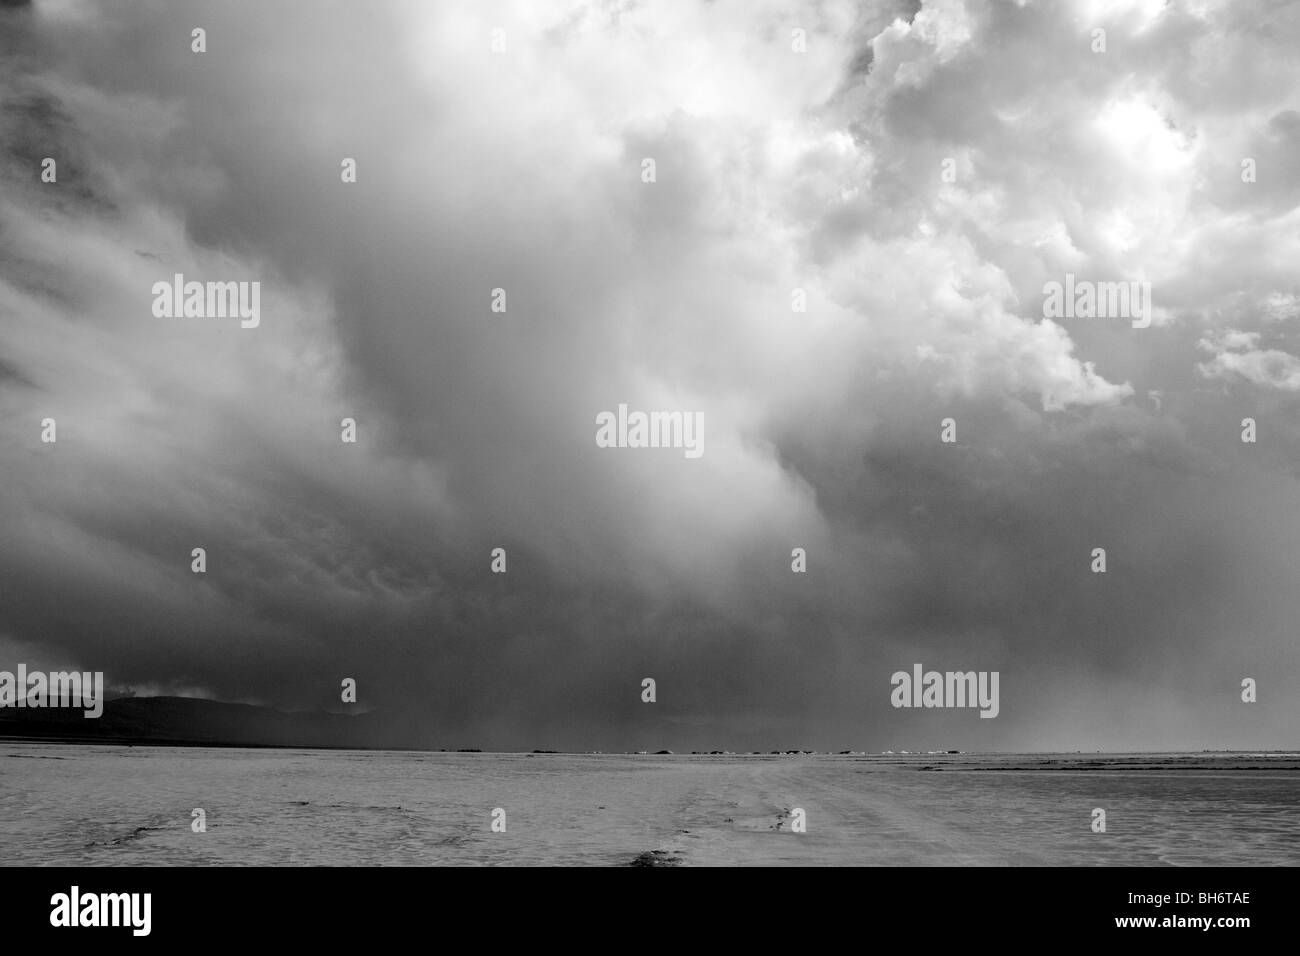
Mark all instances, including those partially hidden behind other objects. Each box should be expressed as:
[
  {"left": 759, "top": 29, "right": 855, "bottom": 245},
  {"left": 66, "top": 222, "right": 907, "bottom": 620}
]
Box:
[{"left": 0, "top": 0, "right": 1300, "bottom": 750}]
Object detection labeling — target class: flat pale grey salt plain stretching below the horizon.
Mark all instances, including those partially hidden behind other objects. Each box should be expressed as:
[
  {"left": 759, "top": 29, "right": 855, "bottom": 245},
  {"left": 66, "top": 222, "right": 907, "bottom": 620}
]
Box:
[{"left": 0, "top": 741, "right": 1300, "bottom": 865}]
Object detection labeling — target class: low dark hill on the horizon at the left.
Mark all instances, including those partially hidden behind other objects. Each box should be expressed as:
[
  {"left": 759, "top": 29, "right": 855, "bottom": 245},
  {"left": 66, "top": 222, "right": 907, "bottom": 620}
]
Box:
[{"left": 0, "top": 697, "right": 417, "bottom": 749}]
